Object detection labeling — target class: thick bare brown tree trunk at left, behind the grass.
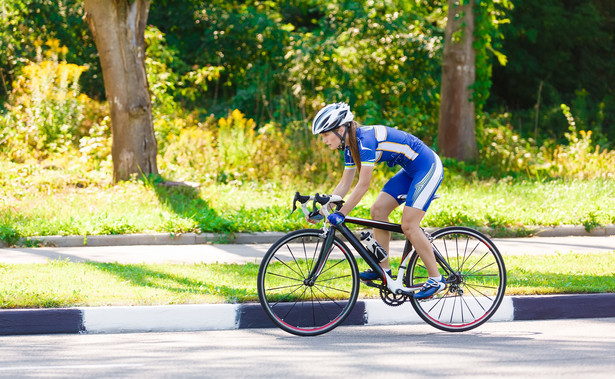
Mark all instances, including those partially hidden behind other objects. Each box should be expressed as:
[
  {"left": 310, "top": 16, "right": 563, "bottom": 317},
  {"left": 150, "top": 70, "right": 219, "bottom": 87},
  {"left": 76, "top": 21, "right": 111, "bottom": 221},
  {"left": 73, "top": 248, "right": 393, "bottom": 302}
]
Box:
[{"left": 84, "top": 0, "right": 158, "bottom": 183}]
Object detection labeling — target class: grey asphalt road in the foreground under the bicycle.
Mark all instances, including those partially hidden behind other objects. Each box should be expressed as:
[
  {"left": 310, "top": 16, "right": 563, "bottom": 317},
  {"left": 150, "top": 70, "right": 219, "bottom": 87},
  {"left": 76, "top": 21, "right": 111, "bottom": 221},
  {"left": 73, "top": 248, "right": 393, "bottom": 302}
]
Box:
[{"left": 0, "top": 318, "right": 615, "bottom": 379}]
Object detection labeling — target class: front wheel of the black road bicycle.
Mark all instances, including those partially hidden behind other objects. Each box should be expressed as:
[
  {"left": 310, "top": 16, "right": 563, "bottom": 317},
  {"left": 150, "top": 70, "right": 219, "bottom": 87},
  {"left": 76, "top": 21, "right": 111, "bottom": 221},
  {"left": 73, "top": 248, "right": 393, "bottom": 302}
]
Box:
[{"left": 257, "top": 229, "right": 359, "bottom": 336}]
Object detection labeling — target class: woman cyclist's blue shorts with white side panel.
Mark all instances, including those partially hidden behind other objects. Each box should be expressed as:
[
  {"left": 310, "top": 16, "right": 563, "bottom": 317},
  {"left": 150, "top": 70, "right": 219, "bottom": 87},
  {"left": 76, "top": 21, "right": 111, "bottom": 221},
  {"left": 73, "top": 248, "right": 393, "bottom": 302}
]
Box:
[{"left": 382, "top": 147, "right": 444, "bottom": 211}]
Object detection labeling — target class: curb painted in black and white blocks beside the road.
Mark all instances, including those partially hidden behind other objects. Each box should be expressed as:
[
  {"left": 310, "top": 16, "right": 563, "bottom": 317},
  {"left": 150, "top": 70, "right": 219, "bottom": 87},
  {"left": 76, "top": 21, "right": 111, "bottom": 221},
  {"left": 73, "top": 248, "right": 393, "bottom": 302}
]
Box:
[{"left": 0, "top": 293, "right": 615, "bottom": 336}]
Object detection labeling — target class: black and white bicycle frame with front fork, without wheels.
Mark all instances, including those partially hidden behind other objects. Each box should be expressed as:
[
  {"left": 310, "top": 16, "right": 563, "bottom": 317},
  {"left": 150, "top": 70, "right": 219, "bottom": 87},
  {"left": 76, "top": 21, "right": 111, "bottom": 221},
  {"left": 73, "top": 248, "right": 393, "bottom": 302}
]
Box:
[{"left": 306, "top": 217, "right": 456, "bottom": 295}]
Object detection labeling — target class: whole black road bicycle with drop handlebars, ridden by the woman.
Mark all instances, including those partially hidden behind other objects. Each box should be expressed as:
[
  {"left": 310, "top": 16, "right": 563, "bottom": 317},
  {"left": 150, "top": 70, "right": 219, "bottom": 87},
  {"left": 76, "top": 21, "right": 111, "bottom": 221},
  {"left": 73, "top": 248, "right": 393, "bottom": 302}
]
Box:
[{"left": 258, "top": 192, "right": 506, "bottom": 336}]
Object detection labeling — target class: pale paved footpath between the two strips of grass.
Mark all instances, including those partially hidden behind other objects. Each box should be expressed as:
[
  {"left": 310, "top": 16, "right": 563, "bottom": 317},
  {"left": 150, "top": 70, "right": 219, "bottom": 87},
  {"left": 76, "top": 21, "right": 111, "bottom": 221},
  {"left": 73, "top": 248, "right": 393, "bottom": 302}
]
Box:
[{"left": 0, "top": 236, "right": 615, "bottom": 264}]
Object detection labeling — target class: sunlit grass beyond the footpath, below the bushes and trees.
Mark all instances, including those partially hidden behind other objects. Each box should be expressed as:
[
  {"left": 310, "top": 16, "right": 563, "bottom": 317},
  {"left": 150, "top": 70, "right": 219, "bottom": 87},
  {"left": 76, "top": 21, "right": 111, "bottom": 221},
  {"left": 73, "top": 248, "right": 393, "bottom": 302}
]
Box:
[{"left": 0, "top": 155, "right": 615, "bottom": 244}]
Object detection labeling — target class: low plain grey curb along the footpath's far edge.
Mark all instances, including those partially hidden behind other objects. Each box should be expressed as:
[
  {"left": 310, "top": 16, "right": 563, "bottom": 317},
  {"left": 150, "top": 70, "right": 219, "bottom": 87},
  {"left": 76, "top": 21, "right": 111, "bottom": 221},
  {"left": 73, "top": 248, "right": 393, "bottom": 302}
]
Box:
[{"left": 12, "top": 224, "right": 615, "bottom": 247}]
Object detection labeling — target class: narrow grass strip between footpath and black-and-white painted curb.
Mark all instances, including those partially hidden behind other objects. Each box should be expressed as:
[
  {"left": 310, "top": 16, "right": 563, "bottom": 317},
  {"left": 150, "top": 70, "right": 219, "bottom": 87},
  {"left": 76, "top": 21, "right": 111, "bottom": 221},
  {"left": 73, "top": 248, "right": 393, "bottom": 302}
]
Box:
[{"left": 0, "top": 249, "right": 615, "bottom": 308}]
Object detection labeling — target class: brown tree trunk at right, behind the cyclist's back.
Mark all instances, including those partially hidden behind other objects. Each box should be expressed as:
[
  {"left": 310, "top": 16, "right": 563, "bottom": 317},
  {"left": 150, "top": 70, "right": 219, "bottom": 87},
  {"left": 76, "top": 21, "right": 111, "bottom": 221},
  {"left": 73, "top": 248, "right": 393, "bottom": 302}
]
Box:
[{"left": 438, "top": 0, "right": 478, "bottom": 161}]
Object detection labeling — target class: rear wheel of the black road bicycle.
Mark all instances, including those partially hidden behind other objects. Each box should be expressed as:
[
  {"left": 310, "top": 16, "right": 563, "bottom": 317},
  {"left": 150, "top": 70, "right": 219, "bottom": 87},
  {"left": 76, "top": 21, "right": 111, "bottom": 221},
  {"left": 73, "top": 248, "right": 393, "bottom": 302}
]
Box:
[{"left": 405, "top": 227, "right": 506, "bottom": 332}]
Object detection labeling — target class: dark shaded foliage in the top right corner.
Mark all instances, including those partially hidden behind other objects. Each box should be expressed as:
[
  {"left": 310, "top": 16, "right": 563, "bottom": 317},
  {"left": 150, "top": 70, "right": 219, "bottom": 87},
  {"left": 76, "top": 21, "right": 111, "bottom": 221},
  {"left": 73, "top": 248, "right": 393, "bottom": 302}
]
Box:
[{"left": 487, "top": 0, "right": 615, "bottom": 144}]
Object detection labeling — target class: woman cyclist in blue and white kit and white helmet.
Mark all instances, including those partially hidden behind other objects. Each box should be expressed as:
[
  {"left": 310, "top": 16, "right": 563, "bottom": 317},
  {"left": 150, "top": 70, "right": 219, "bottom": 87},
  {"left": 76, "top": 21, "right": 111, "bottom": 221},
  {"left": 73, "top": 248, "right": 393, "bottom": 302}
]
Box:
[{"left": 312, "top": 103, "right": 446, "bottom": 299}]
